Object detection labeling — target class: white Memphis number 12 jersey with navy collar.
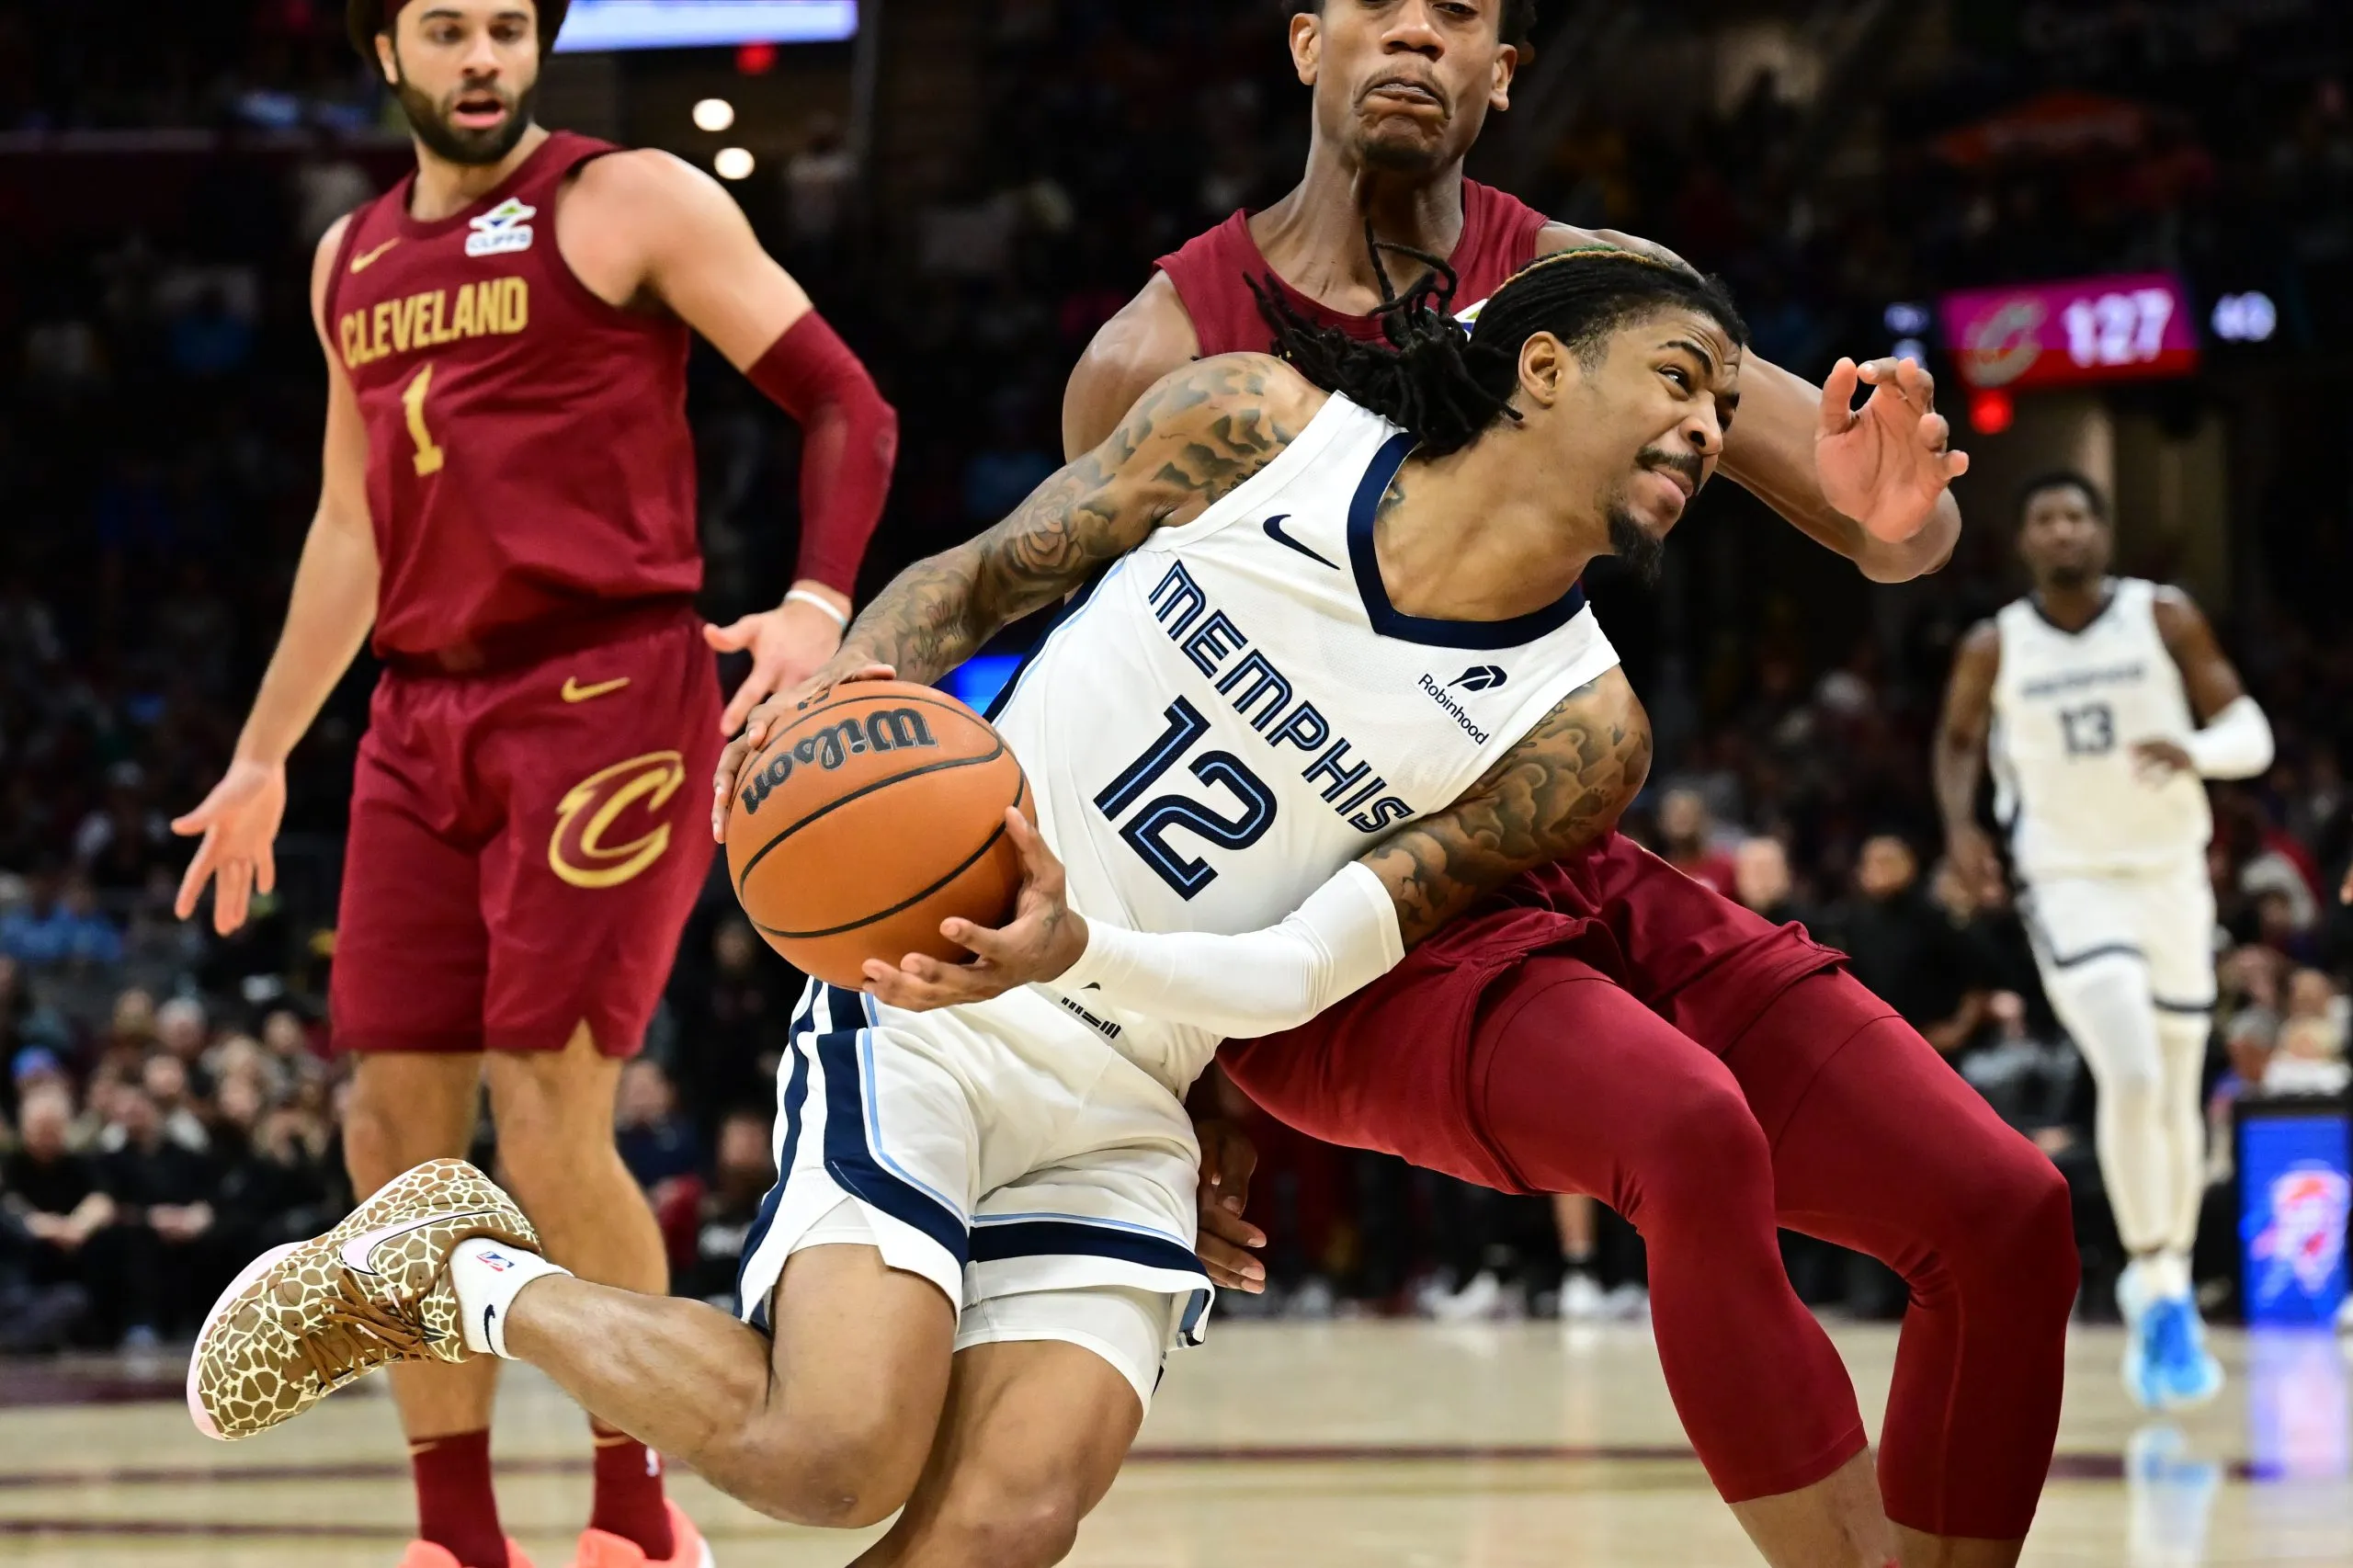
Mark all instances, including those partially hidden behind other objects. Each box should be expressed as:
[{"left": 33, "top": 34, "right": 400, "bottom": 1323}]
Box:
[{"left": 993, "top": 395, "right": 1617, "bottom": 1095}]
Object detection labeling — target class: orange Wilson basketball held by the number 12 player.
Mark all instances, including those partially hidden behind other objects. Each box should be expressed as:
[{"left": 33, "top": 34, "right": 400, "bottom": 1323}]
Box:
[{"left": 727, "top": 680, "right": 1038, "bottom": 986}]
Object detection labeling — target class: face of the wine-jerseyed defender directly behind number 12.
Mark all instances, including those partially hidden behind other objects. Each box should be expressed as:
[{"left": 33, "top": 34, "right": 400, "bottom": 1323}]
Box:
[{"left": 1291, "top": 0, "right": 1520, "bottom": 172}]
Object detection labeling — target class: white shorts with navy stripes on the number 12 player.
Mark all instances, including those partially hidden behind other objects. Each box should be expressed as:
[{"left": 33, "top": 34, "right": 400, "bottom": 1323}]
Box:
[{"left": 736, "top": 980, "right": 1211, "bottom": 1408}]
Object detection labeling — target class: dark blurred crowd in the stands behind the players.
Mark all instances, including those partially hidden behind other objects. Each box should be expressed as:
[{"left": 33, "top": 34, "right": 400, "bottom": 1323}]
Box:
[{"left": 0, "top": 0, "right": 2353, "bottom": 1349}]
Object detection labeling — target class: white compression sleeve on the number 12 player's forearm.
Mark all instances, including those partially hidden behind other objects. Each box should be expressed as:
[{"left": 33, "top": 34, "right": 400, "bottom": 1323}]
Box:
[{"left": 1051, "top": 862, "right": 1404, "bottom": 1039}]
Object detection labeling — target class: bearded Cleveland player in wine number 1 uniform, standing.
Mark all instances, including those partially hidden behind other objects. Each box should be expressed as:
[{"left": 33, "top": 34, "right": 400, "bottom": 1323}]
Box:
[{"left": 174, "top": 0, "right": 896, "bottom": 1568}]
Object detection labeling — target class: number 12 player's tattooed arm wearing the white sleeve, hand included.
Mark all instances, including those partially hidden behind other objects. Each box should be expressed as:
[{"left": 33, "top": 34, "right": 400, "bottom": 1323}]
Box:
[{"left": 866, "top": 668, "right": 1650, "bottom": 1039}]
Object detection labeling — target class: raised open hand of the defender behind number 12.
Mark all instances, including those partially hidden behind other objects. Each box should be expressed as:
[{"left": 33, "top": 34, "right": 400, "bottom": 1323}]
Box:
[{"left": 1814, "top": 358, "right": 1970, "bottom": 544}]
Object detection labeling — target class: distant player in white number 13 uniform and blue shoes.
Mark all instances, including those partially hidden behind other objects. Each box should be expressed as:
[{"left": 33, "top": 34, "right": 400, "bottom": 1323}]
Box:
[{"left": 1937, "top": 473, "right": 2270, "bottom": 1410}]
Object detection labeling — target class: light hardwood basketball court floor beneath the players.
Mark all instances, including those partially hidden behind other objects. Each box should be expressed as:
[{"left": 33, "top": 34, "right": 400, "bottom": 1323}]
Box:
[{"left": 0, "top": 1324, "right": 2353, "bottom": 1568}]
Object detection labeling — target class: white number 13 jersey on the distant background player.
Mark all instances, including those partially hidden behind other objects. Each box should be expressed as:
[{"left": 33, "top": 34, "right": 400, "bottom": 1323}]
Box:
[{"left": 1988, "top": 577, "right": 2214, "bottom": 881}]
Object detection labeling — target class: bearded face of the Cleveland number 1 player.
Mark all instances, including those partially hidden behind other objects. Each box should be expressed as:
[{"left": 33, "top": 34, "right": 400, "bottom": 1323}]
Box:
[{"left": 377, "top": 0, "right": 539, "bottom": 165}]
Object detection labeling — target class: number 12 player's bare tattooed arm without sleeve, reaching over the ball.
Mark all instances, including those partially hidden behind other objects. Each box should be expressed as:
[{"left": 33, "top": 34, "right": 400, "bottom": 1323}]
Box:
[{"left": 710, "top": 353, "right": 1329, "bottom": 838}]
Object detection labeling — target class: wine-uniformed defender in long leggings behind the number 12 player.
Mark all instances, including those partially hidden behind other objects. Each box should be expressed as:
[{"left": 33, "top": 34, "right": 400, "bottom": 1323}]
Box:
[{"left": 1063, "top": 0, "right": 2075, "bottom": 1568}]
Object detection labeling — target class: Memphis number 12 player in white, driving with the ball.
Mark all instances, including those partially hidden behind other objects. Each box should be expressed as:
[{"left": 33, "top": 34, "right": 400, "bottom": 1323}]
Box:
[{"left": 190, "top": 250, "right": 1732, "bottom": 1568}]
